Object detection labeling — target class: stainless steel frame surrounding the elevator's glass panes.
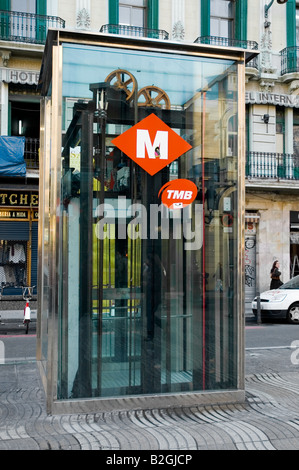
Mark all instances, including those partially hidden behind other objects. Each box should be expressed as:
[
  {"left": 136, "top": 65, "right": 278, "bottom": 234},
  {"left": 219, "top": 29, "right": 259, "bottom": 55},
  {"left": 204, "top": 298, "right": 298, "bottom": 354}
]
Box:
[{"left": 37, "top": 30, "right": 256, "bottom": 413}]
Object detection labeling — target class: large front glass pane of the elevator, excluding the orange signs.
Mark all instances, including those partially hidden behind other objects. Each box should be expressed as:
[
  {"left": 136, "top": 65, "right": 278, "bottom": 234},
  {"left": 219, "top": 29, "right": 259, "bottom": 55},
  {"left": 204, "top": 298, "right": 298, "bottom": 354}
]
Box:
[{"left": 58, "top": 44, "right": 238, "bottom": 398}]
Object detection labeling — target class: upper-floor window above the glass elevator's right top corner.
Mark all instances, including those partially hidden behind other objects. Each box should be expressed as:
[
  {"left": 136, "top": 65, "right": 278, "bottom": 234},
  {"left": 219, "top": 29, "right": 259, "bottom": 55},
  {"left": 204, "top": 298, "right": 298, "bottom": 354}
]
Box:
[{"left": 210, "top": 0, "right": 235, "bottom": 38}]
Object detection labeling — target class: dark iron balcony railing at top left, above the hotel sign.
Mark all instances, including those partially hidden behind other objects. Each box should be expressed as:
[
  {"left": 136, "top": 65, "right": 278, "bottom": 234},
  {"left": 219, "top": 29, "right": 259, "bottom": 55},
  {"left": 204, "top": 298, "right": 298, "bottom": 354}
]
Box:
[{"left": 0, "top": 10, "right": 65, "bottom": 44}]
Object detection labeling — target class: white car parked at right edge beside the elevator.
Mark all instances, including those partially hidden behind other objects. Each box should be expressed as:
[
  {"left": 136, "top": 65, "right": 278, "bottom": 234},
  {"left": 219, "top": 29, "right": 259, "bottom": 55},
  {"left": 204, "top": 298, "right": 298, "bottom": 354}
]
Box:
[{"left": 251, "top": 276, "right": 299, "bottom": 324}]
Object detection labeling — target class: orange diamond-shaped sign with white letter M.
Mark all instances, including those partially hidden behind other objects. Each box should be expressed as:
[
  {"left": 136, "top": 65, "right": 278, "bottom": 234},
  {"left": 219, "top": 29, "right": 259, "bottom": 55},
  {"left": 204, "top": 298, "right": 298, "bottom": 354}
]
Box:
[{"left": 112, "top": 114, "right": 192, "bottom": 176}]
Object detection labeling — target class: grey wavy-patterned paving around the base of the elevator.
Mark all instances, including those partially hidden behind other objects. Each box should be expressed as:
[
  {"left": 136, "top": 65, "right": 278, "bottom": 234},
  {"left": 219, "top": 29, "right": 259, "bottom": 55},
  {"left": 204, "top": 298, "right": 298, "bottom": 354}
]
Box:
[{"left": 0, "top": 362, "right": 299, "bottom": 452}]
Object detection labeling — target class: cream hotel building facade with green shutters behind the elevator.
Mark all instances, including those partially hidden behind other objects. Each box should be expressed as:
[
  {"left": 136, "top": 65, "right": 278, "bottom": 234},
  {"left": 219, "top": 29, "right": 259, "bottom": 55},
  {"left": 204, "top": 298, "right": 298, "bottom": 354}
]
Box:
[{"left": 0, "top": 0, "right": 299, "bottom": 406}]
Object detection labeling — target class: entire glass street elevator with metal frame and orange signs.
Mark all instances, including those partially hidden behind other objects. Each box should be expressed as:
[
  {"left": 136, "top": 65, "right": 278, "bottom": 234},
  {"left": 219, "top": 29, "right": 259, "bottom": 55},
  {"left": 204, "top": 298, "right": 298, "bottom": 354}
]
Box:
[{"left": 37, "top": 30, "right": 252, "bottom": 413}]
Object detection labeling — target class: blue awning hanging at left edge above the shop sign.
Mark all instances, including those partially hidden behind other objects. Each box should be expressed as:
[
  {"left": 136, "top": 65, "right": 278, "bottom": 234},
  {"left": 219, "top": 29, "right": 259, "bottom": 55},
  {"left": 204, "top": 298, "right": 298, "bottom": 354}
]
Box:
[{"left": 0, "top": 136, "right": 26, "bottom": 176}]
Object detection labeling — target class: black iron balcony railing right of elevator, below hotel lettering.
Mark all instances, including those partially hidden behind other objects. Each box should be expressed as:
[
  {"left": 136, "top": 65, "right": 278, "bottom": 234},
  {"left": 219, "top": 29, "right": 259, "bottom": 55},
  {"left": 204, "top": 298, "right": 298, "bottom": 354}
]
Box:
[{"left": 246, "top": 152, "right": 299, "bottom": 181}]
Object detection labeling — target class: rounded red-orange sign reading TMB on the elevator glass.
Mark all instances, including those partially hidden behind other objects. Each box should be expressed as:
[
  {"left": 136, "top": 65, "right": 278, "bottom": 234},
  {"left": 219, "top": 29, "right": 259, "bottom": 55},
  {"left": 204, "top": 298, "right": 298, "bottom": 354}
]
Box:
[{"left": 158, "top": 178, "right": 197, "bottom": 209}]
